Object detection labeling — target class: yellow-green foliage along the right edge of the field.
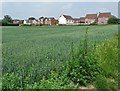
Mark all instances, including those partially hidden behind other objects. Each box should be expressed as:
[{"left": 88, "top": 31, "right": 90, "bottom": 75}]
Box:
[{"left": 94, "top": 37, "right": 118, "bottom": 80}]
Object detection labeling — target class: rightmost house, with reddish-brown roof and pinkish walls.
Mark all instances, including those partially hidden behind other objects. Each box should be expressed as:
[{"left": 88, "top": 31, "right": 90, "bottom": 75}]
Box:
[{"left": 98, "top": 12, "right": 112, "bottom": 24}]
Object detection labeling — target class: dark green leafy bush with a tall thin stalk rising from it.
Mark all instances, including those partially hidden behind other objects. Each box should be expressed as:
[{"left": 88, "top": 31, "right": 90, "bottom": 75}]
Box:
[{"left": 67, "top": 30, "right": 101, "bottom": 86}]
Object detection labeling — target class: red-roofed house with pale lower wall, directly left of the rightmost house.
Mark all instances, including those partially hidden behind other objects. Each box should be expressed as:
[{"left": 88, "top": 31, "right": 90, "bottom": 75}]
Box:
[{"left": 85, "top": 14, "right": 97, "bottom": 24}]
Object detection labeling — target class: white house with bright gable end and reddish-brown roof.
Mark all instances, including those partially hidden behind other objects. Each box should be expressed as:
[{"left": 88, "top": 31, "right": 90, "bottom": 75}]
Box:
[{"left": 58, "top": 15, "right": 74, "bottom": 24}]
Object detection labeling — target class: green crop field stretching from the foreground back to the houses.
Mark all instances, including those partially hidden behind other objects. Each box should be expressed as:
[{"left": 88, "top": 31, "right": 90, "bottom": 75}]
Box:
[{"left": 2, "top": 25, "right": 118, "bottom": 88}]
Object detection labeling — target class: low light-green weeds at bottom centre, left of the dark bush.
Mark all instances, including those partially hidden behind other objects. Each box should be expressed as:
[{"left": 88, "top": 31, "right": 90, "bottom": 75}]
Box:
[{"left": 27, "top": 71, "right": 76, "bottom": 89}]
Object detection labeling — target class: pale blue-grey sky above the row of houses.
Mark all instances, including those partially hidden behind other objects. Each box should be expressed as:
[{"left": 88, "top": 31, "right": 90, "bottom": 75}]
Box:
[{"left": 0, "top": 2, "right": 118, "bottom": 19}]
